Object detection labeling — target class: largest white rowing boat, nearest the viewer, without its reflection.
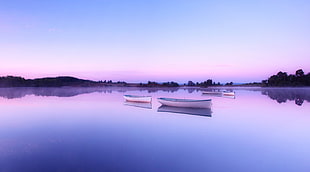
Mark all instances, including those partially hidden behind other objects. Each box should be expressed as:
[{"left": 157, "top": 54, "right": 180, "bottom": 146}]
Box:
[{"left": 158, "top": 98, "right": 211, "bottom": 108}]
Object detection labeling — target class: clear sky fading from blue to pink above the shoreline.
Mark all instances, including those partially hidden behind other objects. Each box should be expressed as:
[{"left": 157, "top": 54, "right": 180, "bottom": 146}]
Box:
[{"left": 0, "top": 0, "right": 310, "bottom": 82}]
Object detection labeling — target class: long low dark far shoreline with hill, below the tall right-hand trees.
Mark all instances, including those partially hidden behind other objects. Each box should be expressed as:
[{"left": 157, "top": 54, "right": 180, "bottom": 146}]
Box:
[{"left": 0, "top": 76, "right": 309, "bottom": 89}]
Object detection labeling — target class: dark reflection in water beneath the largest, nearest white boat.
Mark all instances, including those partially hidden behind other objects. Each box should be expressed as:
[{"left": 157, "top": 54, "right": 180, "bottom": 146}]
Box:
[{"left": 157, "top": 105, "right": 212, "bottom": 117}]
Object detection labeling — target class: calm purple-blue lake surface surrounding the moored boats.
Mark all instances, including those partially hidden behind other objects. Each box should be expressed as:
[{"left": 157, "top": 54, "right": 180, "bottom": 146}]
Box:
[{"left": 0, "top": 87, "right": 310, "bottom": 172}]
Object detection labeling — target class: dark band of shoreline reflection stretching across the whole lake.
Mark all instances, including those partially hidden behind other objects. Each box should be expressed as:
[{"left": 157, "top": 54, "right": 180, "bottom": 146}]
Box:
[{"left": 0, "top": 87, "right": 310, "bottom": 106}]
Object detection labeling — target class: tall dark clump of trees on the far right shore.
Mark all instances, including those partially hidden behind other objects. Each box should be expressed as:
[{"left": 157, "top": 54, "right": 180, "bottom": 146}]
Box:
[{"left": 262, "top": 69, "right": 310, "bottom": 87}]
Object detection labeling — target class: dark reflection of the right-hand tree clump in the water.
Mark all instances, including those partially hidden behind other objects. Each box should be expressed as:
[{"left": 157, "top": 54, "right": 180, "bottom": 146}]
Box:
[{"left": 262, "top": 88, "right": 310, "bottom": 106}]
